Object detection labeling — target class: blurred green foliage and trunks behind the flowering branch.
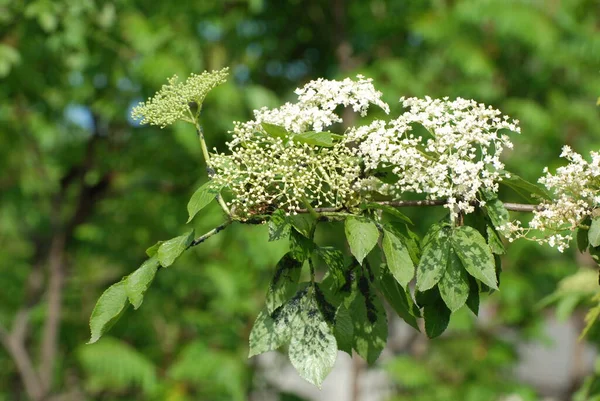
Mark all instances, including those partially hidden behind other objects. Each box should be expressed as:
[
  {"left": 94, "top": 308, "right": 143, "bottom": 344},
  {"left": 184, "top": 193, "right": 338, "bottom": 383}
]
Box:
[{"left": 0, "top": 0, "right": 600, "bottom": 401}]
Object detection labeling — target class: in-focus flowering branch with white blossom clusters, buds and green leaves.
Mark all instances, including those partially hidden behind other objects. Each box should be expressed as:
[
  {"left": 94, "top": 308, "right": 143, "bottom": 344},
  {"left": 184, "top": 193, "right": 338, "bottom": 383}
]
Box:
[{"left": 90, "top": 71, "right": 600, "bottom": 386}]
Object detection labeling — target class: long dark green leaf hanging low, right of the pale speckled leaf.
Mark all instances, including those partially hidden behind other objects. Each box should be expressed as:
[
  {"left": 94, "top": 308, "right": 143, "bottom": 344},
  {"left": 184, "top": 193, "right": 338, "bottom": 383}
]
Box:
[{"left": 350, "top": 277, "right": 388, "bottom": 364}]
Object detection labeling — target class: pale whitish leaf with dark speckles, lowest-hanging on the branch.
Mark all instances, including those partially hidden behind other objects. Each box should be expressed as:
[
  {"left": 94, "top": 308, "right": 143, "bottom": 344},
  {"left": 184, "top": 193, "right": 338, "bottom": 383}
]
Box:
[{"left": 288, "top": 296, "right": 338, "bottom": 388}]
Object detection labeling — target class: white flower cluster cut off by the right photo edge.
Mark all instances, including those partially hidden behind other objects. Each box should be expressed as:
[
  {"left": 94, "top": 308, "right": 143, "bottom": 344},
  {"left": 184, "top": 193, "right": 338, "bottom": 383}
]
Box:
[{"left": 502, "top": 146, "right": 600, "bottom": 252}]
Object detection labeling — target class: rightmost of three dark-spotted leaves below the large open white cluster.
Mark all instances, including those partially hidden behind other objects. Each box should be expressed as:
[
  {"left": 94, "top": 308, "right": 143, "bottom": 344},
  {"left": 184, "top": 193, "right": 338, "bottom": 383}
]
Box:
[{"left": 452, "top": 226, "right": 498, "bottom": 290}]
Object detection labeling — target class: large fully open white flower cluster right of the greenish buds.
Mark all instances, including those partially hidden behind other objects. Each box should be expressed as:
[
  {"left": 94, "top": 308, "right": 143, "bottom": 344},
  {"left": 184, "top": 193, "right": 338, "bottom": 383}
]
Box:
[{"left": 347, "top": 97, "right": 520, "bottom": 216}]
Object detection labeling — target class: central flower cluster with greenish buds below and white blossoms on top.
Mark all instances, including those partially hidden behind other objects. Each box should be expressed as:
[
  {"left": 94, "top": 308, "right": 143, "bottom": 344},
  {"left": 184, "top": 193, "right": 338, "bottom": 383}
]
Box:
[{"left": 210, "top": 76, "right": 389, "bottom": 217}]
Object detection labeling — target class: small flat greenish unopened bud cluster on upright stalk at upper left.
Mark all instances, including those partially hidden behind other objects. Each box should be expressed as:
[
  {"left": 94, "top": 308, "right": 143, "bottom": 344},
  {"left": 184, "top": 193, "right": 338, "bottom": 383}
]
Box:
[{"left": 131, "top": 68, "right": 228, "bottom": 128}]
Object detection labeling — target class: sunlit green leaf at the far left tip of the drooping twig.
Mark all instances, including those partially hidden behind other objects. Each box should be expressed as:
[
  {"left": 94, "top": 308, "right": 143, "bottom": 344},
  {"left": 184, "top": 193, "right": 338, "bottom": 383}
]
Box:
[{"left": 88, "top": 280, "right": 127, "bottom": 344}]
